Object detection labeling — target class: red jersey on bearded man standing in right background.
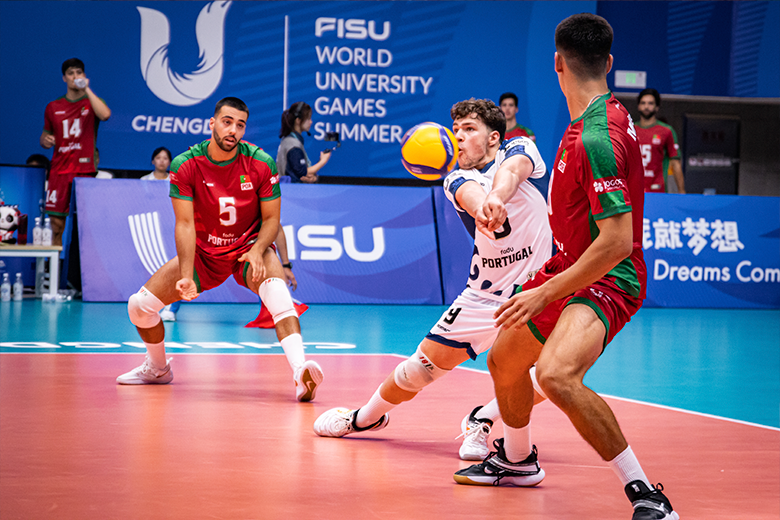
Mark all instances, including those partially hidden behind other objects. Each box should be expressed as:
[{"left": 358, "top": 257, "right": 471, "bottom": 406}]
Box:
[{"left": 636, "top": 121, "right": 679, "bottom": 193}]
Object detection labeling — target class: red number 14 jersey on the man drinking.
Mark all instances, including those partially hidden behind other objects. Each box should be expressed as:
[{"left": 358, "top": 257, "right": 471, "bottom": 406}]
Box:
[{"left": 43, "top": 95, "right": 100, "bottom": 174}]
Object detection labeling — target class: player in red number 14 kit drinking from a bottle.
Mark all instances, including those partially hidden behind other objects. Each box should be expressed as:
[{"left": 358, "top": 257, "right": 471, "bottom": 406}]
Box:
[{"left": 40, "top": 58, "right": 111, "bottom": 246}]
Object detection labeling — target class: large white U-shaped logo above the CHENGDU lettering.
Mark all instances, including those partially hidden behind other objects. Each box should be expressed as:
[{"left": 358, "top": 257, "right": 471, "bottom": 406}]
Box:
[{"left": 136, "top": 2, "right": 232, "bottom": 107}]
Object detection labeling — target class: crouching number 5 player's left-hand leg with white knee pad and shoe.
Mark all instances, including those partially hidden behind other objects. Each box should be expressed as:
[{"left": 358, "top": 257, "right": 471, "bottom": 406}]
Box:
[{"left": 117, "top": 256, "right": 181, "bottom": 384}]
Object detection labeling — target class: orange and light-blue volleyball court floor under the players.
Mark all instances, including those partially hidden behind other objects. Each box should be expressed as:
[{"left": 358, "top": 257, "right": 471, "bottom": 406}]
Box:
[{"left": 0, "top": 300, "right": 780, "bottom": 520}]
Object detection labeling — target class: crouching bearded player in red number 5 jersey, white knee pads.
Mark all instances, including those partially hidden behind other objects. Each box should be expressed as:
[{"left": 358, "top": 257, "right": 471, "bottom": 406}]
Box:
[{"left": 117, "top": 97, "right": 323, "bottom": 401}]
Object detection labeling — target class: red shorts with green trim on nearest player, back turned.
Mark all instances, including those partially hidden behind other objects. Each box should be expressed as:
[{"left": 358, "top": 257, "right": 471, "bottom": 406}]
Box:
[{"left": 518, "top": 253, "right": 642, "bottom": 347}]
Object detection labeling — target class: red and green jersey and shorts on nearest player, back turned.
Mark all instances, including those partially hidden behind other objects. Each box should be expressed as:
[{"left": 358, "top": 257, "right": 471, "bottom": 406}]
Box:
[{"left": 520, "top": 92, "right": 647, "bottom": 345}]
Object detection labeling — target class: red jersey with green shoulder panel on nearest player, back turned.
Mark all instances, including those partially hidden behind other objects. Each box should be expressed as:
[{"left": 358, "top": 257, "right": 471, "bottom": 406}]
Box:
[{"left": 547, "top": 92, "right": 647, "bottom": 299}]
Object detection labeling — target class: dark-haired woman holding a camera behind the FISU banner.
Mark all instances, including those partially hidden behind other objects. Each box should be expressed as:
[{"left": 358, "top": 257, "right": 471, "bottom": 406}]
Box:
[{"left": 276, "top": 101, "right": 330, "bottom": 183}]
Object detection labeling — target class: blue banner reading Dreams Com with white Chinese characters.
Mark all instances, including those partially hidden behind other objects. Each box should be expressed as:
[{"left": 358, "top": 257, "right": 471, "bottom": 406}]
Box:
[{"left": 643, "top": 193, "right": 780, "bottom": 309}]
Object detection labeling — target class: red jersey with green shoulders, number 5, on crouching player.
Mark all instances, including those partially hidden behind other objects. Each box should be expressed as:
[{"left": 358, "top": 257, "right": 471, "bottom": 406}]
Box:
[{"left": 170, "top": 140, "right": 281, "bottom": 260}]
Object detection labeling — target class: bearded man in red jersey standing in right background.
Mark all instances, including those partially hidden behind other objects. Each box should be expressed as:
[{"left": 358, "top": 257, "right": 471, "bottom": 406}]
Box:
[{"left": 636, "top": 88, "right": 685, "bottom": 193}]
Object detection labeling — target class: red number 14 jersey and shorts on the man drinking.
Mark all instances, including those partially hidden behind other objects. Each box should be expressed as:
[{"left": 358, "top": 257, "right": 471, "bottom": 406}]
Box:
[{"left": 43, "top": 95, "right": 100, "bottom": 216}]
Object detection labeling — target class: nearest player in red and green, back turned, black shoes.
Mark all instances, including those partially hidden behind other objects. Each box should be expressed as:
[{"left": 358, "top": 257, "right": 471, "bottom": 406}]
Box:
[{"left": 456, "top": 13, "right": 679, "bottom": 520}]
